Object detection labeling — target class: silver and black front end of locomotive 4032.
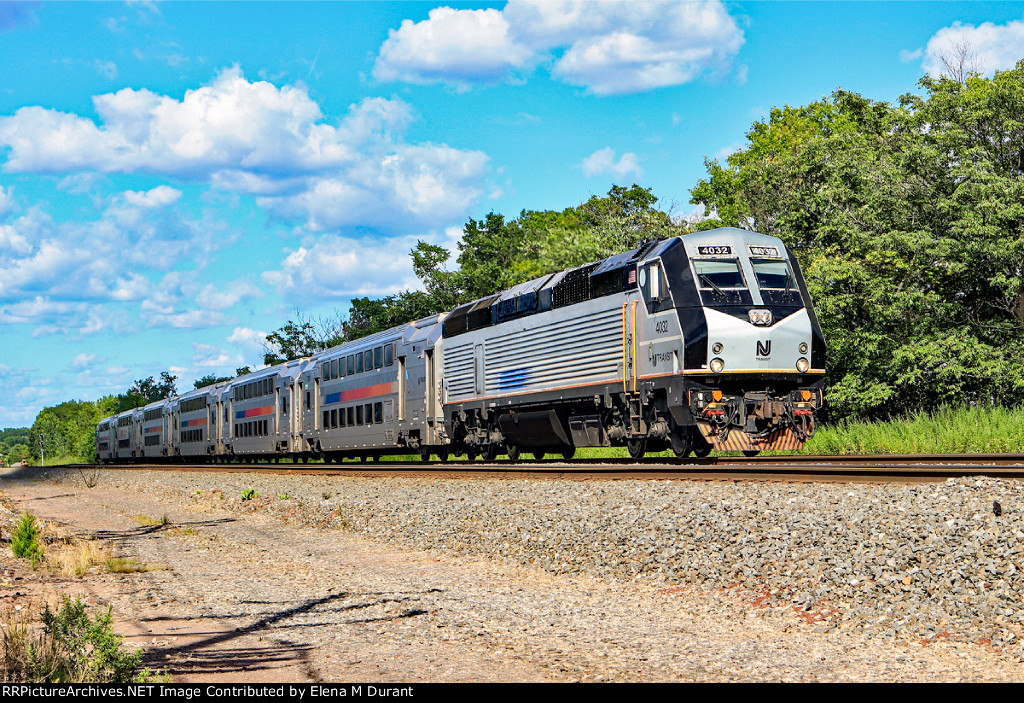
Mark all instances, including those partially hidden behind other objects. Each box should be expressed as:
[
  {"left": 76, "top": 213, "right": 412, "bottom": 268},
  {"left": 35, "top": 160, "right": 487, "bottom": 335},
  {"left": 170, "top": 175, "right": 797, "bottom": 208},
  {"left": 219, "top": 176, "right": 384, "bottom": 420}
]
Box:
[{"left": 667, "top": 228, "right": 825, "bottom": 453}]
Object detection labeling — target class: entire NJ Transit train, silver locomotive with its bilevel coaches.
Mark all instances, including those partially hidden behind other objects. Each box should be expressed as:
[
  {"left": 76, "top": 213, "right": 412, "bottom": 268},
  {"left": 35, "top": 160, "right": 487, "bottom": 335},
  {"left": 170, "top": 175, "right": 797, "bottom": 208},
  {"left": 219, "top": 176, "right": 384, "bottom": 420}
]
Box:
[{"left": 96, "top": 227, "right": 825, "bottom": 462}]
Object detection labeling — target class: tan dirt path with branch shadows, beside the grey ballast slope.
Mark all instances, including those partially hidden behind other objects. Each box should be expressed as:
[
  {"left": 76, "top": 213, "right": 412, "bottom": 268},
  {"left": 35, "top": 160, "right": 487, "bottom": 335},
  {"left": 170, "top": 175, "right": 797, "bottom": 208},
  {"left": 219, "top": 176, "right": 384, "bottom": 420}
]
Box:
[{"left": 0, "top": 472, "right": 1021, "bottom": 683}]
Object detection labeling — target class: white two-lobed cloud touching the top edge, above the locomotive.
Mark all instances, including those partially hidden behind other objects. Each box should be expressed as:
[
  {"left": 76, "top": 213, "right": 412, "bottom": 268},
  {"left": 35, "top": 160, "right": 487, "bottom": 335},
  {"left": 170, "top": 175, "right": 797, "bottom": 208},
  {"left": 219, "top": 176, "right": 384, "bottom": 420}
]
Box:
[{"left": 374, "top": 0, "right": 743, "bottom": 95}]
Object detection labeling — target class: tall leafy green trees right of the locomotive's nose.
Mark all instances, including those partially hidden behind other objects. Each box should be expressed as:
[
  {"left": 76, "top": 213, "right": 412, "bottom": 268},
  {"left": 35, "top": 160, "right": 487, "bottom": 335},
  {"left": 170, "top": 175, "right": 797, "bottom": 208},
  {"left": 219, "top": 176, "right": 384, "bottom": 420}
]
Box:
[{"left": 691, "top": 63, "right": 1024, "bottom": 416}]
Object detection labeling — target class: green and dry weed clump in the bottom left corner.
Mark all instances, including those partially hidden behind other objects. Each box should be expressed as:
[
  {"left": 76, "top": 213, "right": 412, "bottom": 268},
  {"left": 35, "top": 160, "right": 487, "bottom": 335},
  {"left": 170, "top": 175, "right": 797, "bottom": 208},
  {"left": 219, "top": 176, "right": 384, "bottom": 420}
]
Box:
[{"left": 0, "top": 596, "right": 161, "bottom": 684}]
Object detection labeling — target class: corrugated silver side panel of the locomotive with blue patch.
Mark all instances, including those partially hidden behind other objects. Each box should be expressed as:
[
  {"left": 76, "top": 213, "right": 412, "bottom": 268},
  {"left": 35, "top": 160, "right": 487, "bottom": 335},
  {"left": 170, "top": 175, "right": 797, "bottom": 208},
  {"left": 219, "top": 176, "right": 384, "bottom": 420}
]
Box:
[{"left": 444, "top": 301, "right": 623, "bottom": 402}]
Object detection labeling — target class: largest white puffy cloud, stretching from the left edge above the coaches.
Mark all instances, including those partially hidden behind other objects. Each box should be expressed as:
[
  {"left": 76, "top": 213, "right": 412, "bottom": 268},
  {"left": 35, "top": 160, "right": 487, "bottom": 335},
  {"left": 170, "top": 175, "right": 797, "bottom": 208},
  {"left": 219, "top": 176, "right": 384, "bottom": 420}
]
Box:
[{"left": 0, "top": 68, "right": 487, "bottom": 229}]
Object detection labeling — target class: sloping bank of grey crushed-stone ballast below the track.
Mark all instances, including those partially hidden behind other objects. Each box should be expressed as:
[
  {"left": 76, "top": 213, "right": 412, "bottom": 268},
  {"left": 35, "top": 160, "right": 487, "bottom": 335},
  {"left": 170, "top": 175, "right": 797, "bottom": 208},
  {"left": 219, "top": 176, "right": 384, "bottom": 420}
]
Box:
[{"left": 12, "top": 470, "right": 1024, "bottom": 680}]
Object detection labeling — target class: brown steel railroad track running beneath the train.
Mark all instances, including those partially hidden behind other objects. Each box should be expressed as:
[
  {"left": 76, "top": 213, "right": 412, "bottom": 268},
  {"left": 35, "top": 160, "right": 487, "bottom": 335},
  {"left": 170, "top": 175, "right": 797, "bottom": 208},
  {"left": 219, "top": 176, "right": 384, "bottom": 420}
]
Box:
[{"left": 41, "top": 454, "right": 1024, "bottom": 482}]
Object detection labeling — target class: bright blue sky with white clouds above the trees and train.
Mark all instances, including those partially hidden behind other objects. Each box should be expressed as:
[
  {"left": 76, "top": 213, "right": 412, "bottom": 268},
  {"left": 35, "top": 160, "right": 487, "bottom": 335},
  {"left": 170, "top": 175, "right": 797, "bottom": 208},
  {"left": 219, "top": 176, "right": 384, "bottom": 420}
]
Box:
[{"left": 0, "top": 1, "right": 1024, "bottom": 427}]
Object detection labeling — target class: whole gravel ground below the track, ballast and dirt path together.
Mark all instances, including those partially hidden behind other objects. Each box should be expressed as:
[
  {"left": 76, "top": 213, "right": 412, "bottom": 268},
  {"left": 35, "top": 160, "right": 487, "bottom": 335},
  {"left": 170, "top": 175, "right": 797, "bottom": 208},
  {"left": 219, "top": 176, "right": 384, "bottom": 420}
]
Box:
[{"left": 0, "top": 470, "right": 1024, "bottom": 683}]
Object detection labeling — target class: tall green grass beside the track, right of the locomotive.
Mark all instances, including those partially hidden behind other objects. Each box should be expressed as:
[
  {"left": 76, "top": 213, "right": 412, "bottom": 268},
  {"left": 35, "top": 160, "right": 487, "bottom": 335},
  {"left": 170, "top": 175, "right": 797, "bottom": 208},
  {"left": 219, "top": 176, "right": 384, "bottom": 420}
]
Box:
[{"left": 801, "top": 407, "right": 1024, "bottom": 454}]
